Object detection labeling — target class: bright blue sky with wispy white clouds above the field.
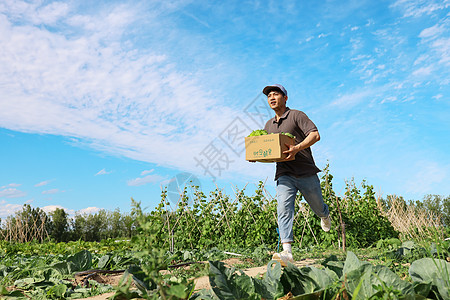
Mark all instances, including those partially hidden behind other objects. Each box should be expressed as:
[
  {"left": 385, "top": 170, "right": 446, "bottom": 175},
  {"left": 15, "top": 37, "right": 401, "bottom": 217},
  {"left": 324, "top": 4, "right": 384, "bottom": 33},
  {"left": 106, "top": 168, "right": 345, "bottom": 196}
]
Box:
[{"left": 0, "top": 0, "right": 450, "bottom": 218}]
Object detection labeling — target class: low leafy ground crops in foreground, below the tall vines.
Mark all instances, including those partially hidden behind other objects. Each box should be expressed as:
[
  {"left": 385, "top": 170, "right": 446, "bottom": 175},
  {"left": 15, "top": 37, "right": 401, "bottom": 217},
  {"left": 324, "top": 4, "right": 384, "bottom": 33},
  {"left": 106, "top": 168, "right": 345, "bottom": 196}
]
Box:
[{"left": 0, "top": 240, "right": 450, "bottom": 299}]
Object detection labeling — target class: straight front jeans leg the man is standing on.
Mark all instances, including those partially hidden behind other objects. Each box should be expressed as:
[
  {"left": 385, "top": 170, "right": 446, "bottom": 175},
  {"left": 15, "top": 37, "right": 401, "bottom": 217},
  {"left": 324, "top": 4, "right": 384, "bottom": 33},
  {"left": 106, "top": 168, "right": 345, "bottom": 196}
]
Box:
[{"left": 277, "top": 176, "right": 297, "bottom": 243}]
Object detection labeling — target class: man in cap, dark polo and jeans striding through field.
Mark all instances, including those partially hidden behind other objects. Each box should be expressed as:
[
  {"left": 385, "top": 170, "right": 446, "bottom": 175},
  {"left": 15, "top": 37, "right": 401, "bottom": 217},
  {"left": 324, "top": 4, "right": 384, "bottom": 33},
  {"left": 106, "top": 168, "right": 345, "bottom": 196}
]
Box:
[{"left": 263, "top": 84, "right": 331, "bottom": 266}]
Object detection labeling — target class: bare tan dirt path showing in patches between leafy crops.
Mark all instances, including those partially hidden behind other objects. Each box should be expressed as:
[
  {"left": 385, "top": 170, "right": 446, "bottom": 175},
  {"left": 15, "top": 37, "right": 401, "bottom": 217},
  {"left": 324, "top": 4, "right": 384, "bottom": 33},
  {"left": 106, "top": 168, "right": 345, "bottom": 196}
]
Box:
[{"left": 75, "top": 258, "right": 317, "bottom": 300}]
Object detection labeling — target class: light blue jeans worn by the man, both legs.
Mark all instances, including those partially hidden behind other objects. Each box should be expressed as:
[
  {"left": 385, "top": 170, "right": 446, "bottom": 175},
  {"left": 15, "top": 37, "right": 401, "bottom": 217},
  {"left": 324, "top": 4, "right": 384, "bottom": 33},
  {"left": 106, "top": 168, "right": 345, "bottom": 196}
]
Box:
[{"left": 277, "top": 174, "right": 329, "bottom": 243}]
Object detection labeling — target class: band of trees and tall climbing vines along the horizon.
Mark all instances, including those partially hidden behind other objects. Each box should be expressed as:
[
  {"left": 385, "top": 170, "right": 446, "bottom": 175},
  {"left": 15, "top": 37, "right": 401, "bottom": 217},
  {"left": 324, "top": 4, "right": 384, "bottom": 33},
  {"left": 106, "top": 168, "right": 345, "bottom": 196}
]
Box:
[{"left": 0, "top": 172, "right": 450, "bottom": 248}]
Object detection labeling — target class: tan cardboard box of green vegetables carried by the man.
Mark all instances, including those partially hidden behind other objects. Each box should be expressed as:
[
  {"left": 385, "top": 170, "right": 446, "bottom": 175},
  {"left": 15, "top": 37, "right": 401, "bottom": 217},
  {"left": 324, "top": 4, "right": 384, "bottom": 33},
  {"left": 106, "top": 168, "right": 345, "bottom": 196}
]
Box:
[{"left": 245, "top": 133, "right": 295, "bottom": 162}]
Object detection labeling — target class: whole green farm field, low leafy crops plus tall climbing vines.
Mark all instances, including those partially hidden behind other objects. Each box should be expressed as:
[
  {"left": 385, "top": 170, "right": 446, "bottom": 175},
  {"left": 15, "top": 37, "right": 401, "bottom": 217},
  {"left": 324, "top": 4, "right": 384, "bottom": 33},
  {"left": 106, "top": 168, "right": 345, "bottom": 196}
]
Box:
[{"left": 0, "top": 173, "right": 450, "bottom": 299}]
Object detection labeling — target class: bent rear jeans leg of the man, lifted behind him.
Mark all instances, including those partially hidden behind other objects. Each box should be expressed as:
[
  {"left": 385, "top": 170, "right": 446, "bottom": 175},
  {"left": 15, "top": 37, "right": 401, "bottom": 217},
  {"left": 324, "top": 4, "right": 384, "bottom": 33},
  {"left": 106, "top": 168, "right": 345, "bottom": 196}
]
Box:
[{"left": 295, "top": 175, "right": 329, "bottom": 218}]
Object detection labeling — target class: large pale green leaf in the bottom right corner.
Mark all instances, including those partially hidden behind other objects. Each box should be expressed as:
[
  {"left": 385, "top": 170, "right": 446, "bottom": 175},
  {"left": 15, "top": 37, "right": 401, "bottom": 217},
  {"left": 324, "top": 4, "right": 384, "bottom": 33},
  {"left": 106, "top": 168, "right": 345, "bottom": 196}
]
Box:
[{"left": 409, "top": 258, "right": 450, "bottom": 299}]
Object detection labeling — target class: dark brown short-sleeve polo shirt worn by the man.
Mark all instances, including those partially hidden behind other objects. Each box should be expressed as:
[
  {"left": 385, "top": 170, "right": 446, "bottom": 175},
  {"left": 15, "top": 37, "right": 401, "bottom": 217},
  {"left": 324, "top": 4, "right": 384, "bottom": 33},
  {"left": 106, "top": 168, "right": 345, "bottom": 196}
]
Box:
[{"left": 264, "top": 107, "right": 320, "bottom": 180}]
